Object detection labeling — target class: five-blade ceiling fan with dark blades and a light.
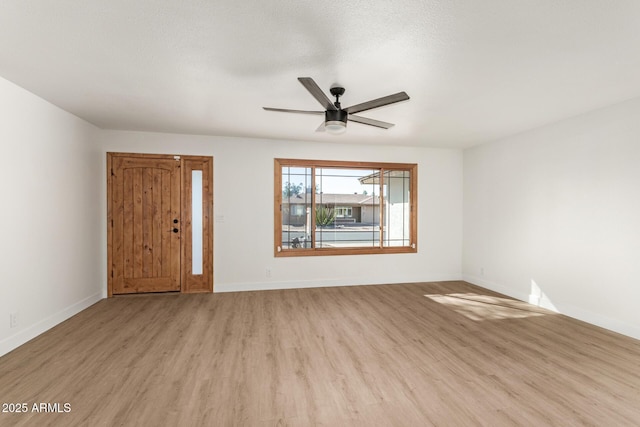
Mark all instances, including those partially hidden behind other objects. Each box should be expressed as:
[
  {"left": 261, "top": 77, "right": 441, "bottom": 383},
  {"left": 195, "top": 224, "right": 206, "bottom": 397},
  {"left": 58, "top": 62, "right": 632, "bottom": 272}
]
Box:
[{"left": 262, "top": 77, "right": 409, "bottom": 134}]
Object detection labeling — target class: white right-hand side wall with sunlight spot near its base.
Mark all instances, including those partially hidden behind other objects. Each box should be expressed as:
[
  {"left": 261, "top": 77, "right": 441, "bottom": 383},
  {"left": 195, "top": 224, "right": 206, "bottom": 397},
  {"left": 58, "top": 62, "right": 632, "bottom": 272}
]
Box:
[{"left": 463, "top": 99, "right": 640, "bottom": 338}]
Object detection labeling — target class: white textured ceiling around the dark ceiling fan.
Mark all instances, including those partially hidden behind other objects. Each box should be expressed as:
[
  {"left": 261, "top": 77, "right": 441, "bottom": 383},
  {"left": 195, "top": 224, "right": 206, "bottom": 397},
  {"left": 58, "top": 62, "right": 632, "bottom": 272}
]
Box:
[{"left": 0, "top": 0, "right": 640, "bottom": 147}]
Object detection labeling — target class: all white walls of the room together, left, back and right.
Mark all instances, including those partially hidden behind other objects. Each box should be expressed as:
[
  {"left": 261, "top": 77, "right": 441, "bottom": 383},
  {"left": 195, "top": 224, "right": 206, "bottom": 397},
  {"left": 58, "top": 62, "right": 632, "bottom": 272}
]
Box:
[{"left": 0, "top": 69, "right": 640, "bottom": 355}]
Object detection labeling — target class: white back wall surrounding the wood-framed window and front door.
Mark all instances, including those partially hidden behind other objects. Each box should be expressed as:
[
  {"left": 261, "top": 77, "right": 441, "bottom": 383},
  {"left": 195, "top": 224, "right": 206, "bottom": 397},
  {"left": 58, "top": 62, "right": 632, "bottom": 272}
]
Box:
[{"left": 101, "top": 131, "right": 462, "bottom": 292}]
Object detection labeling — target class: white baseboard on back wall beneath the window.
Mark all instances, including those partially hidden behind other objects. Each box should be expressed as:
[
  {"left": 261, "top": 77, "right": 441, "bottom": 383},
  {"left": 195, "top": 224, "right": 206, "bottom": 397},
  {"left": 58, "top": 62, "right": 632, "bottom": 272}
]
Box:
[{"left": 218, "top": 274, "right": 462, "bottom": 292}]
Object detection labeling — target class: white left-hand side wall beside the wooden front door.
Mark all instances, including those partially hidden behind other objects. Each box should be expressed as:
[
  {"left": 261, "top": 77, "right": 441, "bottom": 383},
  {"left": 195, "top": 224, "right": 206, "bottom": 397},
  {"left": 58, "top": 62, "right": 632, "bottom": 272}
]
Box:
[{"left": 0, "top": 78, "right": 104, "bottom": 355}]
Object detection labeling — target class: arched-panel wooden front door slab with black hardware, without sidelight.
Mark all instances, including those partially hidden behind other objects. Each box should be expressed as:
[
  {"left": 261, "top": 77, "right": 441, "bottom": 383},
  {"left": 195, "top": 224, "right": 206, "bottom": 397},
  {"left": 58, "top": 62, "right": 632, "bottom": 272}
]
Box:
[{"left": 111, "top": 156, "right": 182, "bottom": 294}]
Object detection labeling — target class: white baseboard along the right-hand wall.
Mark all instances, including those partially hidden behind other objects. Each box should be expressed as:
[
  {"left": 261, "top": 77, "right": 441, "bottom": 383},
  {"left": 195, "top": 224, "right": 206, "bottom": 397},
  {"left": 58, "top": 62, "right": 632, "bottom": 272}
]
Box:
[{"left": 462, "top": 274, "right": 640, "bottom": 340}]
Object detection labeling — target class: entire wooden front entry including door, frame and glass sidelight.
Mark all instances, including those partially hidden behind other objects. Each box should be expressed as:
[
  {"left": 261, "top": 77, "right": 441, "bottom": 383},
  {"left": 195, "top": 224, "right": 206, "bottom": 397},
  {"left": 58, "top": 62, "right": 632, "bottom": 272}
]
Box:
[{"left": 107, "top": 153, "right": 213, "bottom": 296}]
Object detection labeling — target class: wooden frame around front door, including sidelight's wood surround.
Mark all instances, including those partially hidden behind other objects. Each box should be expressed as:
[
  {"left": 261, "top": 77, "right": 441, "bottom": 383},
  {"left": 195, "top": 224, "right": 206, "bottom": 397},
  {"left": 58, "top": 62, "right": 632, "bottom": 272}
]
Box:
[{"left": 106, "top": 152, "right": 213, "bottom": 298}]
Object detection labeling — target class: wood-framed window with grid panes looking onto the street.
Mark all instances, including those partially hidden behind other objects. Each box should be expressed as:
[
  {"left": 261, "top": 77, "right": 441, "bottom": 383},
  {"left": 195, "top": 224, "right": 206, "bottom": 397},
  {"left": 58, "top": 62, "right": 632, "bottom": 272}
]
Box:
[{"left": 274, "top": 159, "right": 417, "bottom": 256}]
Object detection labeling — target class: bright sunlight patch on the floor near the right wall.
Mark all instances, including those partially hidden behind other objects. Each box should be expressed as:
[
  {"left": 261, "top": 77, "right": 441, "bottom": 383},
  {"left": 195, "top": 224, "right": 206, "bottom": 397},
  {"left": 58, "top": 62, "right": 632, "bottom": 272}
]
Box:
[{"left": 425, "top": 293, "right": 550, "bottom": 321}]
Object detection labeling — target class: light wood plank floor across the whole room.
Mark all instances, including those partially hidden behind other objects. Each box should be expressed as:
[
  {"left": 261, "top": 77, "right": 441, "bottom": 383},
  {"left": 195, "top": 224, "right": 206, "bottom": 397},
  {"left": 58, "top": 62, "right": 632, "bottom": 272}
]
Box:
[{"left": 0, "top": 282, "right": 640, "bottom": 426}]
